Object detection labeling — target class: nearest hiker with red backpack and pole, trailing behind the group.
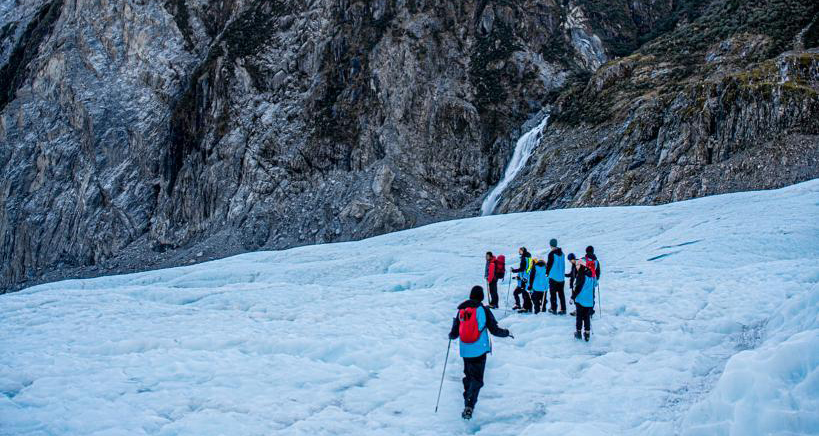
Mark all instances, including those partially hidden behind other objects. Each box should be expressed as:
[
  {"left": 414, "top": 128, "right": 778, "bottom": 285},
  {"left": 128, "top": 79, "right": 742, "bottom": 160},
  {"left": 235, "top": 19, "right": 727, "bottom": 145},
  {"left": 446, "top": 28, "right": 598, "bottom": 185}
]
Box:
[{"left": 449, "top": 286, "right": 515, "bottom": 419}]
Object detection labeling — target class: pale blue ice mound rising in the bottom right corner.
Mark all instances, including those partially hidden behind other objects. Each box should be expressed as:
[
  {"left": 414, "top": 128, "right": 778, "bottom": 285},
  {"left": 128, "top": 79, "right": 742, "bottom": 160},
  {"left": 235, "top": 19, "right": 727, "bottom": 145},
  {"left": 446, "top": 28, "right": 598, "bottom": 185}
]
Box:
[{"left": 683, "top": 286, "right": 819, "bottom": 436}]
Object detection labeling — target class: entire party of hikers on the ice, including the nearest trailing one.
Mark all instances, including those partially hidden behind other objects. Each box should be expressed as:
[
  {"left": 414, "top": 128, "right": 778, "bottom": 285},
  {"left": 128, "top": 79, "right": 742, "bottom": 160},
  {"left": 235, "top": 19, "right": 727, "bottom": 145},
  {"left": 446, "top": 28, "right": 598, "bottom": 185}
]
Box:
[{"left": 448, "top": 239, "right": 601, "bottom": 419}]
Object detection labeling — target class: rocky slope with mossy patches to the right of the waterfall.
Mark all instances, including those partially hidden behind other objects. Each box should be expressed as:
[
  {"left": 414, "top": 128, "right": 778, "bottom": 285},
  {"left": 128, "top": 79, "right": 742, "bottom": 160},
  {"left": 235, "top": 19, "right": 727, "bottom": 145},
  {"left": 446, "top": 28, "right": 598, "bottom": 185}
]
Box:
[{"left": 498, "top": 1, "right": 819, "bottom": 212}]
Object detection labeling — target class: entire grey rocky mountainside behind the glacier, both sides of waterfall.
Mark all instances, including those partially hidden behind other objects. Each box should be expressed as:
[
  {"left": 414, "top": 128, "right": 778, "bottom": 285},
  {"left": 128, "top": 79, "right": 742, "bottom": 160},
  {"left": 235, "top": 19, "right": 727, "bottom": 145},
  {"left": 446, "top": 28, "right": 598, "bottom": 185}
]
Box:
[{"left": 0, "top": 0, "right": 817, "bottom": 289}]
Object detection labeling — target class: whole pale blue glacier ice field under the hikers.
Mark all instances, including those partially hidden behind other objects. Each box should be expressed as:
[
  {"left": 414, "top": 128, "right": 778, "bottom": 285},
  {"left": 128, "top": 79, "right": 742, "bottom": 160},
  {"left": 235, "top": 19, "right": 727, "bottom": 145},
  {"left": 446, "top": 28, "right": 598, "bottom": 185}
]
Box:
[{"left": 0, "top": 180, "right": 819, "bottom": 436}]
